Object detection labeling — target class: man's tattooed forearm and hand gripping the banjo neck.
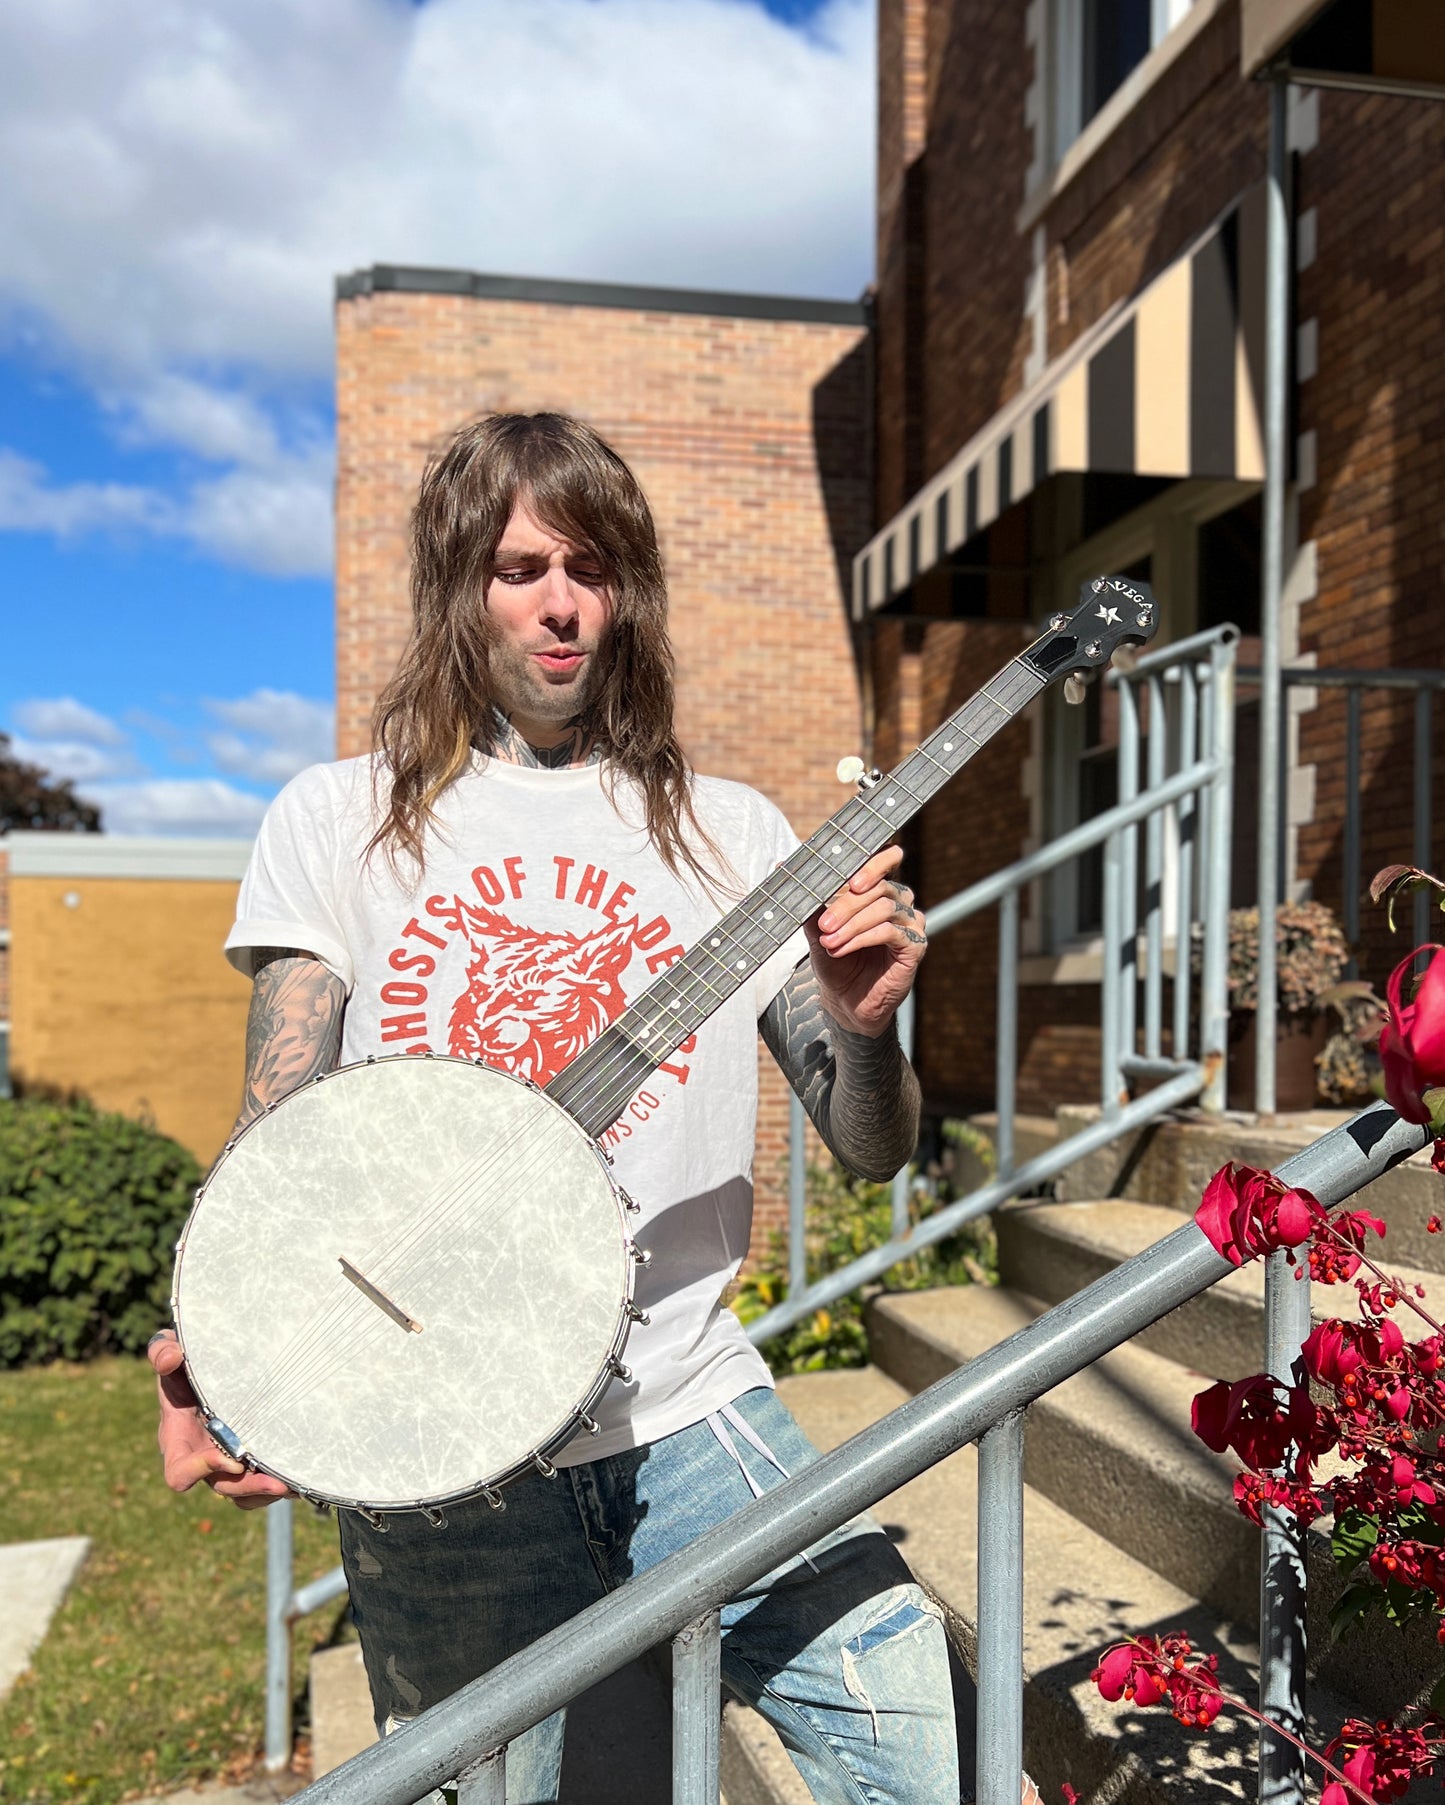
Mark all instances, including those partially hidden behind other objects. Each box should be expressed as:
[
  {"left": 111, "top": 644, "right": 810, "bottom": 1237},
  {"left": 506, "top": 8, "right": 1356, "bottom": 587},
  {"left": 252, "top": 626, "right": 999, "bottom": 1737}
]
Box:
[{"left": 759, "top": 847, "right": 927, "bottom": 1179}]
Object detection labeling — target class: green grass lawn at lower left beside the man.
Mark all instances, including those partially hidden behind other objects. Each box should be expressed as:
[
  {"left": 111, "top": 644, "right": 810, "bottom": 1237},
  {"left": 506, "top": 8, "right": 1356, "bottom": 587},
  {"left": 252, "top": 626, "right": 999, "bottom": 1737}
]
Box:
[{"left": 0, "top": 1359, "right": 345, "bottom": 1805}]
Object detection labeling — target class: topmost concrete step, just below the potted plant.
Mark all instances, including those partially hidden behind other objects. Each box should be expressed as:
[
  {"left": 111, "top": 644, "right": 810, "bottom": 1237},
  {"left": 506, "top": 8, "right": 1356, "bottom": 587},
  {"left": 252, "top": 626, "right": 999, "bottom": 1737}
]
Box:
[{"left": 1059, "top": 1105, "right": 1445, "bottom": 1273}]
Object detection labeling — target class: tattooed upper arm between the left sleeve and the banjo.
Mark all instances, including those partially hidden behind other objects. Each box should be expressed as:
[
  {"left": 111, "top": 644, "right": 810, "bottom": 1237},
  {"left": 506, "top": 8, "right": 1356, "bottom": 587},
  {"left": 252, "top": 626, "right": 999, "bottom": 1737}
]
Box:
[{"left": 236, "top": 946, "right": 346, "bottom": 1130}]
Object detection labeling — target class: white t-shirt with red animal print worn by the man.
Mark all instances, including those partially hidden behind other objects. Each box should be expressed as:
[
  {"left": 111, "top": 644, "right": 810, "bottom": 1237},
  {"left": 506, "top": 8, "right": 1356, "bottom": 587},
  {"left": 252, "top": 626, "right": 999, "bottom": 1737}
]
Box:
[{"left": 225, "top": 754, "right": 808, "bottom": 1466}]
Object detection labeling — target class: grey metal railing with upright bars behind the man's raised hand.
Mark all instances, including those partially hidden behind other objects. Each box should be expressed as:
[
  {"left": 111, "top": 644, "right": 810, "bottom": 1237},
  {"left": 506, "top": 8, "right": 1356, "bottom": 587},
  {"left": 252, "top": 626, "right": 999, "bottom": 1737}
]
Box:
[{"left": 764, "top": 625, "right": 1239, "bottom": 1345}]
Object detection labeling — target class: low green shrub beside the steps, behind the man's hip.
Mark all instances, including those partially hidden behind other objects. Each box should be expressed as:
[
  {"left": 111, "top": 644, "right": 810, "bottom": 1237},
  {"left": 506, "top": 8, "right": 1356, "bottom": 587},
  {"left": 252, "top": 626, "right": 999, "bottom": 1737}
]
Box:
[{"left": 732, "top": 1121, "right": 998, "bottom": 1377}]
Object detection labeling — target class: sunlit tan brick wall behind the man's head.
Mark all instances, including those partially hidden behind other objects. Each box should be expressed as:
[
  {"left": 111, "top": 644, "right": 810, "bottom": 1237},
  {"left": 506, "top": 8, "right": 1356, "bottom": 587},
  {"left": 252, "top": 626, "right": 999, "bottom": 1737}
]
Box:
[{"left": 337, "top": 292, "right": 871, "bottom": 1256}]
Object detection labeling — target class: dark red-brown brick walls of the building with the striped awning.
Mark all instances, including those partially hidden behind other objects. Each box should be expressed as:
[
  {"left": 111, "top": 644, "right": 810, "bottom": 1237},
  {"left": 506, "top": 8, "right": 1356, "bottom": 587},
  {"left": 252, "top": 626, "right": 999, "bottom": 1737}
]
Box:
[{"left": 873, "top": 0, "right": 1445, "bottom": 1103}]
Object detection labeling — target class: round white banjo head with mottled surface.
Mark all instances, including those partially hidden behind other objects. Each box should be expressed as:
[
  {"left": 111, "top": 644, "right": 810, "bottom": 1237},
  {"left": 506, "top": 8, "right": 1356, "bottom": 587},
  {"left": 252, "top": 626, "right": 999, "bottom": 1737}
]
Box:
[{"left": 173, "top": 1056, "right": 635, "bottom": 1511}]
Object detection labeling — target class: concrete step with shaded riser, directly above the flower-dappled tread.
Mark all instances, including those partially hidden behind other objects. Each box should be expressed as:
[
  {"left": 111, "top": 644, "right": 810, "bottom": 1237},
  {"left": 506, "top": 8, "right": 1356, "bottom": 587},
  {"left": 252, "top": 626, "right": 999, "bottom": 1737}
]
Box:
[{"left": 868, "top": 1277, "right": 1440, "bottom": 1713}]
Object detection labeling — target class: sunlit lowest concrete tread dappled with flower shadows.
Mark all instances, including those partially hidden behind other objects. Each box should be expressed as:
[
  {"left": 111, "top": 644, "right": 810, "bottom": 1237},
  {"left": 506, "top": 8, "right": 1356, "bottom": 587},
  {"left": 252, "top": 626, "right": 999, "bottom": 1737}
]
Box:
[{"left": 759, "top": 1368, "right": 1344, "bottom": 1805}]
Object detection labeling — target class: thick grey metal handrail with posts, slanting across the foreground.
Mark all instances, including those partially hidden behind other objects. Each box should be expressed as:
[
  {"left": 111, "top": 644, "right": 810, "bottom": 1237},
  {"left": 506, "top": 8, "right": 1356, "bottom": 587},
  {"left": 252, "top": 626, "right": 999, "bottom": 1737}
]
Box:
[{"left": 299, "top": 1105, "right": 1429, "bottom": 1805}]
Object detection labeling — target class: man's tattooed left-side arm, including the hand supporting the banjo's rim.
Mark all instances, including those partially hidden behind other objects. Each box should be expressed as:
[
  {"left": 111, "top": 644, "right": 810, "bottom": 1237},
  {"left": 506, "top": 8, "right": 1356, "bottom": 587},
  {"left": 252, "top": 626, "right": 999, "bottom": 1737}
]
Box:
[{"left": 146, "top": 946, "right": 346, "bottom": 1511}]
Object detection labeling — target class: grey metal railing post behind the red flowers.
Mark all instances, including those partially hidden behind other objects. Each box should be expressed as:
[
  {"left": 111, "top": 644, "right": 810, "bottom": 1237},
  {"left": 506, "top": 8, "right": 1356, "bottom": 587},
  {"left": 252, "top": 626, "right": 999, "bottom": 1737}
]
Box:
[{"left": 1259, "top": 1247, "right": 1310, "bottom": 1805}]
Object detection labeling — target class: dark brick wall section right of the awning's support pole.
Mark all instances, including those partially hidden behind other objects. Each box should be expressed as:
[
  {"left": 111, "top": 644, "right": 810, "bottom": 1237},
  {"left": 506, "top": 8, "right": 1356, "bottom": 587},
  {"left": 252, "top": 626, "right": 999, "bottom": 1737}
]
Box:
[{"left": 1297, "top": 92, "right": 1445, "bottom": 980}]
